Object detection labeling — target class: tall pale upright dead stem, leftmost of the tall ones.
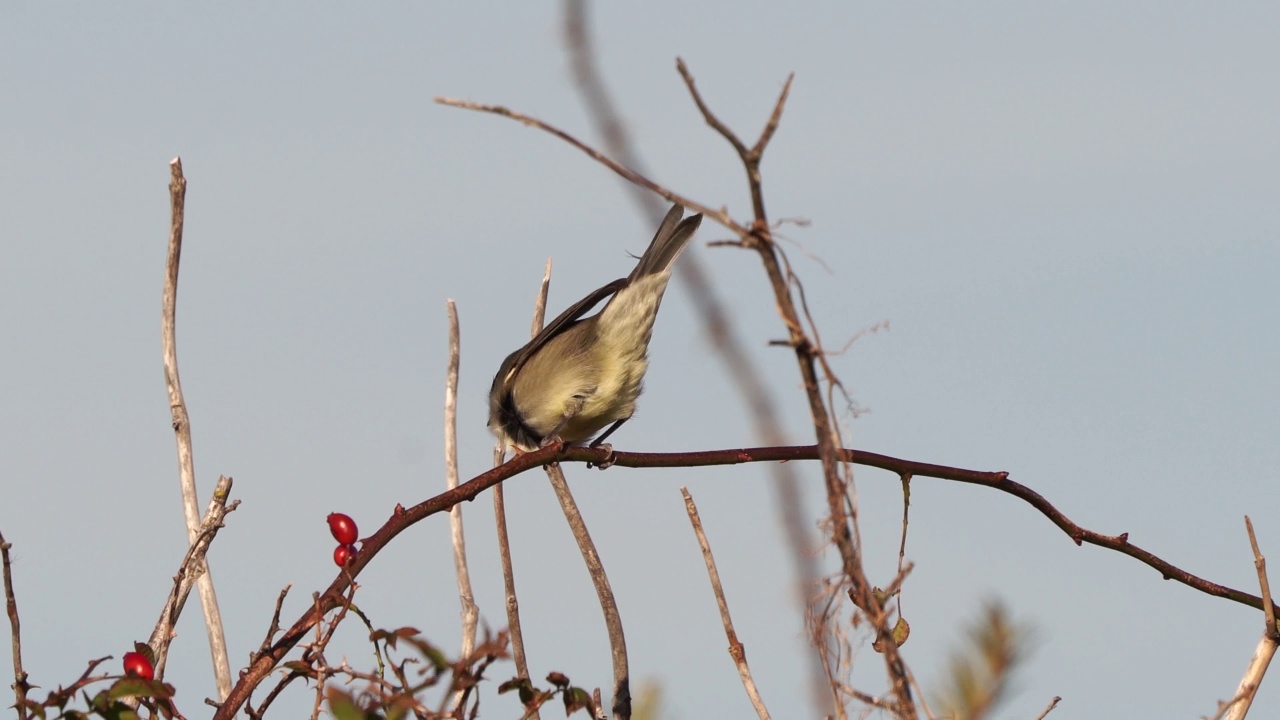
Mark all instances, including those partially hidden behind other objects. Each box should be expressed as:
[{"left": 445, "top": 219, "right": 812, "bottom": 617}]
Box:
[{"left": 160, "top": 158, "right": 232, "bottom": 700}]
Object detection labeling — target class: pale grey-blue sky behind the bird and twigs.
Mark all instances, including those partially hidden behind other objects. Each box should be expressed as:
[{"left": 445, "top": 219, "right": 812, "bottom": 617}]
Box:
[{"left": 0, "top": 1, "right": 1280, "bottom": 720}]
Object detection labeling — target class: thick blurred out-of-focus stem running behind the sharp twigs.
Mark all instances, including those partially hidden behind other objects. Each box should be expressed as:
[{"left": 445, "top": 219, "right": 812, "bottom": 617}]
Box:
[{"left": 564, "top": 0, "right": 831, "bottom": 715}]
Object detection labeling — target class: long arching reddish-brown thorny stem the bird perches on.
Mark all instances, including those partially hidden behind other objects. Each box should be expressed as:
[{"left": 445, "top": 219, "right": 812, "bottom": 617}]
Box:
[{"left": 214, "top": 442, "right": 1262, "bottom": 720}]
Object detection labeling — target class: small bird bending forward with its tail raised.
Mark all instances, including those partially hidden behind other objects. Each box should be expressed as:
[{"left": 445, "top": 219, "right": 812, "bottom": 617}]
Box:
[{"left": 489, "top": 205, "right": 703, "bottom": 451}]
